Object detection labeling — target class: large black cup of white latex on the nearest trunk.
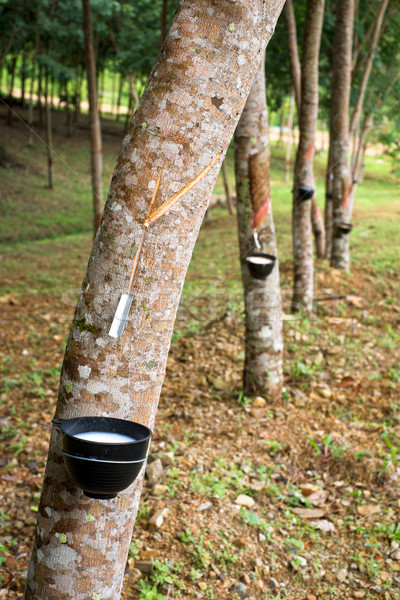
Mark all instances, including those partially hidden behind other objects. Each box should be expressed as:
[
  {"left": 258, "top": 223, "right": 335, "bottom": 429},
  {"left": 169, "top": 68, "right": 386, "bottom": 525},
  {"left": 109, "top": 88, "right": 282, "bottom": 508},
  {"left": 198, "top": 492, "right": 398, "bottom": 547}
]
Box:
[{"left": 52, "top": 417, "right": 152, "bottom": 500}]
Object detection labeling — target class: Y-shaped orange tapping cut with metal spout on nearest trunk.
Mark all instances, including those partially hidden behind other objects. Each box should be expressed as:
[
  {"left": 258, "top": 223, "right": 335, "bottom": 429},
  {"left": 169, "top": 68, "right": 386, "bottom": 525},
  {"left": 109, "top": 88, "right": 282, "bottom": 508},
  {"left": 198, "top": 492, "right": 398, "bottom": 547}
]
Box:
[{"left": 108, "top": 152, "right": 222, "bottom": 339}]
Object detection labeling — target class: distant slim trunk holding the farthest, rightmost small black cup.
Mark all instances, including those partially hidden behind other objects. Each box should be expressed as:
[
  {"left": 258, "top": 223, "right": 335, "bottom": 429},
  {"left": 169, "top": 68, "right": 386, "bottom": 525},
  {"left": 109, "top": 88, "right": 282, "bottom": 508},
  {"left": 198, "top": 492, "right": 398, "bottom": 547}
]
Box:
[{"left": 330, "top": 0, "right": 354, "bottom": 270}]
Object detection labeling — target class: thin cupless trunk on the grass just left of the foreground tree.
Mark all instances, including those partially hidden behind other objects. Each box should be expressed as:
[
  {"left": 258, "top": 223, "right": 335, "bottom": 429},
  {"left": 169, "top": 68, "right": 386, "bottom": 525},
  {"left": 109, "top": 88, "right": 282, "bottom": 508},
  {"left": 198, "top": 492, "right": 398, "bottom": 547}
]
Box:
[{"left": 82, "top": 0, "right": 103, "bottom": 234}]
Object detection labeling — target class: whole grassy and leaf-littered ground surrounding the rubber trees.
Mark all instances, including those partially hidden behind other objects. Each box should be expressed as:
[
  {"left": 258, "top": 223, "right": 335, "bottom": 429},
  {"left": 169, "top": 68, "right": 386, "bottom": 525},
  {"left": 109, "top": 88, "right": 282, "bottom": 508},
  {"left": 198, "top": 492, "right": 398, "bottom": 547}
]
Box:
[{"left": 0, "top": 105, "right": 400, "bottom": 600}]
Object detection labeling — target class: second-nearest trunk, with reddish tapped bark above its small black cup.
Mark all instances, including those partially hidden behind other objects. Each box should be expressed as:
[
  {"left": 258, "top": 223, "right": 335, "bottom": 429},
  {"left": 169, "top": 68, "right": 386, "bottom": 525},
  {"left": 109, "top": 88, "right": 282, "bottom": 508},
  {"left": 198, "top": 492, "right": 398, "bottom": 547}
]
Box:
[{"left": 235, "top": 59, "right": 283, "bottom": 398}]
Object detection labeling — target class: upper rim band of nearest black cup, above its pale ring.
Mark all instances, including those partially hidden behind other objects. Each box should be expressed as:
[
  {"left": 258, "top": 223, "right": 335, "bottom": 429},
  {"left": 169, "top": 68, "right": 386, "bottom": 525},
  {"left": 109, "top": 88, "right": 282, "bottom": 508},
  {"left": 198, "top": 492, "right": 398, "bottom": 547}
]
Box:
[{"left": 53, "top": 417, "right": 151, "bottom": 461}]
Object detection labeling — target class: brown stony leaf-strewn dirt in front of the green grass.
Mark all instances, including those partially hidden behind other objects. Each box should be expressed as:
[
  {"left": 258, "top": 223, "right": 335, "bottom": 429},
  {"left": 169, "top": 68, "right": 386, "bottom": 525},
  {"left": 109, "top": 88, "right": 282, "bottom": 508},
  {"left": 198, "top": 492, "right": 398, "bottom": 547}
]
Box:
[{"left": 0, "top": 256, "right": 400, "bottom": 600}]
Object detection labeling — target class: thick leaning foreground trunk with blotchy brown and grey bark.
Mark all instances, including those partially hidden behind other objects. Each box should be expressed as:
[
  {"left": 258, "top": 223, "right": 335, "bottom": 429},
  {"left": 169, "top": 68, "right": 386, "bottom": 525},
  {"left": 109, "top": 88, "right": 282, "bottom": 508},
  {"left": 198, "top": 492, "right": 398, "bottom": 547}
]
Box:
[{"left": 25, "top": 0, "right": 283, "bottom": 600}]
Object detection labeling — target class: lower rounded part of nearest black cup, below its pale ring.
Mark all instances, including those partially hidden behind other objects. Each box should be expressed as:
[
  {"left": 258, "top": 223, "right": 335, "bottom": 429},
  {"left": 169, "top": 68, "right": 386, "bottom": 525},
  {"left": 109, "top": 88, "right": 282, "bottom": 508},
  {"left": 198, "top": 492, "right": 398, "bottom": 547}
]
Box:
[{"left": 62, "top": 450, "right": 146, "bottom": 500}]
